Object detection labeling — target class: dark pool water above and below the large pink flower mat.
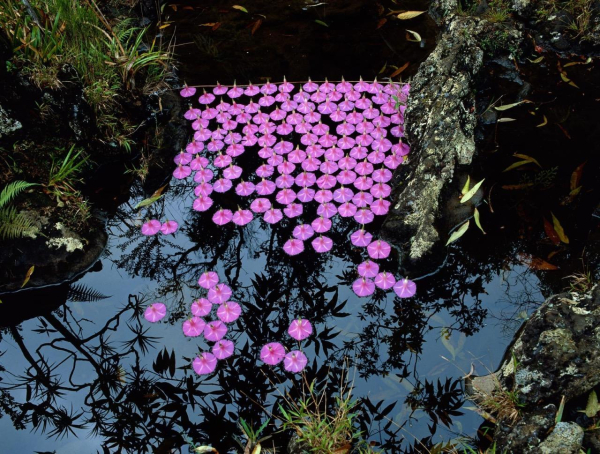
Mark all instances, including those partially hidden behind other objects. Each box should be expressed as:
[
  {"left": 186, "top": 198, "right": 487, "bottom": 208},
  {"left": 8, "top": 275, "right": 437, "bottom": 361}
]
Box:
[{"left": 0, "top": 1, "right": 596, "bottom": 453}]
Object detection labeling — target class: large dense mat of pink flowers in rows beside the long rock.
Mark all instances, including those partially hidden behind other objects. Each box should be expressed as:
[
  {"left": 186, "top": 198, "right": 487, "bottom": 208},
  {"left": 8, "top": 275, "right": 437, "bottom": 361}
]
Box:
[{"left": 178, "top": 78, "right": 416, "bottom": 298}]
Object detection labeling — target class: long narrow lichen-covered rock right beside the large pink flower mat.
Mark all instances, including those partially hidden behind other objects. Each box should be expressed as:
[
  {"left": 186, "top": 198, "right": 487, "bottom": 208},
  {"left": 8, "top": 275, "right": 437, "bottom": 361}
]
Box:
[{"left": 383, "top": 10, "right": 500, "bottom": 272}]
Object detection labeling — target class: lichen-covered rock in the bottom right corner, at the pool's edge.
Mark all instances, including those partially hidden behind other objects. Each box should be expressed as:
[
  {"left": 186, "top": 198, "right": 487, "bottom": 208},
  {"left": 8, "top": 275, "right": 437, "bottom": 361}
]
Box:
[{"left": 480, "top": 285, "right": 600, "bottom": 454}]
